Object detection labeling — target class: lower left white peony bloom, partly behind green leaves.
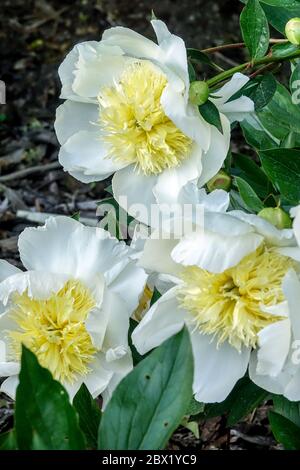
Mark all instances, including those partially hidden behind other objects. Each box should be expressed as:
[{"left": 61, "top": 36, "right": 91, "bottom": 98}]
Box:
[{"left": 0, "top": 217, "right": 146, "bottom": 401}]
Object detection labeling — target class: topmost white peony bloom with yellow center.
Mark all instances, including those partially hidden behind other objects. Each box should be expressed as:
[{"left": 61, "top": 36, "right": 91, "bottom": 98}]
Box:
[{"left": 55, "top": 20, "right": 254, "bottom": 221}]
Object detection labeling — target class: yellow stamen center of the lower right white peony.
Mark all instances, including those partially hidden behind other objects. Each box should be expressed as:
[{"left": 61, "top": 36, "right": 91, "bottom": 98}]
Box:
[{"left": 178, "top": 245, "right": 293, "bottom": 350}]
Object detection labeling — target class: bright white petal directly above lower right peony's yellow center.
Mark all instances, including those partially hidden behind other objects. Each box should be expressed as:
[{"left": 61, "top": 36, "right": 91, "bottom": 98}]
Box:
[{"left": 172, "top": 228, "right": 263, "bottom": 273}]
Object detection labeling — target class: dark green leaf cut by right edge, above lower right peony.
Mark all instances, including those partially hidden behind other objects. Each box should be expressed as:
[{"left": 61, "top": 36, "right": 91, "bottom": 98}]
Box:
[{"left": 260, "top": 149, "right": 300, "bottom": 205}]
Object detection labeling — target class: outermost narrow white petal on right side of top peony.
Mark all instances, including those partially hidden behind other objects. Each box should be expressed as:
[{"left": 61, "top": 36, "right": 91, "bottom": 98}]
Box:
[{"left": 198, "top": 114, "right": 230, "bottom": 187}]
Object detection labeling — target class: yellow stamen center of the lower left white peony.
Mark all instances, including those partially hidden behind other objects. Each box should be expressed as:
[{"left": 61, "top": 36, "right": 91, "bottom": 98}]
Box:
[{"left": 8, "top": 281, "right": 96, "bottom": 383}]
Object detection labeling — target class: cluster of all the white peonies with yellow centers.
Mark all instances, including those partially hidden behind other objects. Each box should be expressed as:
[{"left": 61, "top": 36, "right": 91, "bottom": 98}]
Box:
[{"left": 0, "top": 20, "right": 300, "bottom": 404}]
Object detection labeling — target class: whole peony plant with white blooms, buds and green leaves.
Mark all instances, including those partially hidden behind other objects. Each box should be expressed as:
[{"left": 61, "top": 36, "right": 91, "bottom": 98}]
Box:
[{"left": 0, "top": 0, "right": 300, "bottom": 454}]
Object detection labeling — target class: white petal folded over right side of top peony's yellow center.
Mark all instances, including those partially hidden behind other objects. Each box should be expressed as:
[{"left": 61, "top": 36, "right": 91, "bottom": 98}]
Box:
[{"left": 161, "top": 84, "right": 211, "bottom": 151}]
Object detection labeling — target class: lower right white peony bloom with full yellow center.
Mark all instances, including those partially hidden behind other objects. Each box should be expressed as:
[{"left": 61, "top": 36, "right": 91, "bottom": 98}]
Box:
[{"left": 132, "top": 207, "right": 299, "bottom": 403}]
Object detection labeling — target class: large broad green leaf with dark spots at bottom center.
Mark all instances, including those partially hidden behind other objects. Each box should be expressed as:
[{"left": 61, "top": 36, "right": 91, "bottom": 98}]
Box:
[{"left": 98, "top": 328, "right": 193, "bottom": 450}]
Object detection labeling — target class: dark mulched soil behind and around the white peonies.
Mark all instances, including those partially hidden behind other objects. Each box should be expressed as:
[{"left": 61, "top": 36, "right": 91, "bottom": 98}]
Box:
[{"left": 0, "top": 0, "right": 275, "bottom": 449}]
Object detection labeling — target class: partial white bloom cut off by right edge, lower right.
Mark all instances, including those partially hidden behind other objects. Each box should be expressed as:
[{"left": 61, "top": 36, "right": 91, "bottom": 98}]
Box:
[{"left": 249, "top": 206, "right": 300, "bottom": 401}]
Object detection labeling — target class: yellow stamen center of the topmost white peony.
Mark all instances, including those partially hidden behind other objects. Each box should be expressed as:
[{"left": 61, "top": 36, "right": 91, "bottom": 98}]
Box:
[{"left": 98, "top": 61, "right": 192, "bottom": 175}]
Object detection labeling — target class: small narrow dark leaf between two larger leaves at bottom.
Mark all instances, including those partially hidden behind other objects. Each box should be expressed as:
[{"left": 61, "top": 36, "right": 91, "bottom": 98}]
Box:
[{"left": 73, "top": 384, "right": 101, "bottom": 449}]
